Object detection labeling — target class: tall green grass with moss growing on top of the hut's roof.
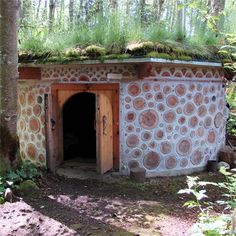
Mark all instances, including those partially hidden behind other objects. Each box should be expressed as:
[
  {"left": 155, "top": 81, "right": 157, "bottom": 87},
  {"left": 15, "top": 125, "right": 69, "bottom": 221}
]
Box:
[{"left": 19, "top": 12, "right": 221, "bottom": 63}]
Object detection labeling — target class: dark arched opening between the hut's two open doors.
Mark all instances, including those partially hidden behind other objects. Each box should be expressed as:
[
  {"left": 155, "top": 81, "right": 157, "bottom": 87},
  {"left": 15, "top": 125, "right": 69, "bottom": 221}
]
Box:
[{"left": 63, "top": 92, "right": 96, "bottom": 163}]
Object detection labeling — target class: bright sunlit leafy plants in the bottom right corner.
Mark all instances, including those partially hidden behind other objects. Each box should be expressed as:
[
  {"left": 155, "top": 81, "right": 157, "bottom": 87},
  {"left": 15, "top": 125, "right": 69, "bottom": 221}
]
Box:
[{"left": 178, "top": 168, "right": 236, "bottom": 236}]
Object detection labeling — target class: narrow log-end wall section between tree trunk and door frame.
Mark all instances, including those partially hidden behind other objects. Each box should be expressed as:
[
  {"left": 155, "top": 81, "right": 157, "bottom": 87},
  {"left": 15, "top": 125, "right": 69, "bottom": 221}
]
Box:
[{"left": 17, "top": 82, "right": 50, "bottom": 166}]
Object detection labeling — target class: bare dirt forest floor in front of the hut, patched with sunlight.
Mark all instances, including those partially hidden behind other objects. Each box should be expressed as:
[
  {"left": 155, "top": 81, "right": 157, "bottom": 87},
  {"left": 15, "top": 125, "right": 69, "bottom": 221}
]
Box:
[{"left": 0, "top": 173, "right": 225, "bottom": 236}]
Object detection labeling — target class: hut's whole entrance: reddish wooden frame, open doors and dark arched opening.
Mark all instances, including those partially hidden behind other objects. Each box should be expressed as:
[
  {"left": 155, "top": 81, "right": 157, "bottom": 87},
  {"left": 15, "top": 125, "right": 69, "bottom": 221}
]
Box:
[{"left": 49, "top": 84, "right": 119, "bottom": 174}]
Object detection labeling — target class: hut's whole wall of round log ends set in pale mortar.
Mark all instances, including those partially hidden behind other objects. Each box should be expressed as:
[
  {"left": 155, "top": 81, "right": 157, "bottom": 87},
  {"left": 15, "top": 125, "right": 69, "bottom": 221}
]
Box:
[{"left": 18, "top": 62, "right": 227, "bottom": 176}]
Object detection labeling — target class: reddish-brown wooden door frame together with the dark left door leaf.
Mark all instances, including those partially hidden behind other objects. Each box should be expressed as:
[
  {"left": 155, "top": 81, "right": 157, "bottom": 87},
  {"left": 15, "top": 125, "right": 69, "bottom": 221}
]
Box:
[{"left": 46, "top": 83, "right": 120, "bottom": 171}]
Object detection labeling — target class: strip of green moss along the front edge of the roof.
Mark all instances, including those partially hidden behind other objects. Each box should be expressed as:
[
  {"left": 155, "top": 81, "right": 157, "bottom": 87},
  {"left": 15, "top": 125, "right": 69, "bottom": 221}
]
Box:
[{"left": 19, "top": 41, "right": 225, "bottom": 63}]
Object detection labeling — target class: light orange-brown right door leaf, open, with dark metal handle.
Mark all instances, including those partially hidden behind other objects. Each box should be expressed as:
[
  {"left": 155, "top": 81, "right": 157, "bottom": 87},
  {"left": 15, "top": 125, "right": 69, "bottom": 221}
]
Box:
[{"left": 96, "top": 91, "right": 113, "bottom": 174}]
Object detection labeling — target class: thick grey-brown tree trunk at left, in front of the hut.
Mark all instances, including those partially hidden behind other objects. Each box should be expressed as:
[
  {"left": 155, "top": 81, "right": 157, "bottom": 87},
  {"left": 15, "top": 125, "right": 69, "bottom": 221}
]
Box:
[{"left": 0, "top": 0, "right": 19, "bottom": 171}]
